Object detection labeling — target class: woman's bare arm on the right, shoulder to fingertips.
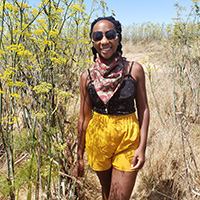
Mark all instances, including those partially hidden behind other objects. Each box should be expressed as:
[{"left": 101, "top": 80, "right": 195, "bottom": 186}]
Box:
[{"left": 131, "top": 62, "right": 149, "bottom": 169}]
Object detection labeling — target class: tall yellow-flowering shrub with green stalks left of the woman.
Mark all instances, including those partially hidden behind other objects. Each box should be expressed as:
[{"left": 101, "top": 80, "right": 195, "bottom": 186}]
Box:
[{"left": 0, "top": 0, "right": 106, "bottom": 199}]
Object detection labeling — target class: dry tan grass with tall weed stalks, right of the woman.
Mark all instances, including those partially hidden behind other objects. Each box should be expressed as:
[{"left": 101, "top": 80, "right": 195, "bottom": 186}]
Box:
[{"left": 124, "top": 1, "right": 200, "bottom": 200}]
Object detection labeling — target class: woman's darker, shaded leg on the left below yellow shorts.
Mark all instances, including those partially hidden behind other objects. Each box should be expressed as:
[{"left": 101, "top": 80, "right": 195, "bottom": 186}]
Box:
[{"left": 96, "top": 168, "right": 112, "bottom": 200}]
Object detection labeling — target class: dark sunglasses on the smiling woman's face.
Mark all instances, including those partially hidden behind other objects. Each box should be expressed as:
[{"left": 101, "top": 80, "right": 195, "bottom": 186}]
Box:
[{"left": 92, "top": 30, "right": 118, "bottom": 42}]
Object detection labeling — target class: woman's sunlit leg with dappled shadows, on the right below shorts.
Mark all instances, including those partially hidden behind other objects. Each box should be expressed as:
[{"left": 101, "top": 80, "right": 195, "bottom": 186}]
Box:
[{"left": 108, "top": 168, "right": 137, "bottom": 200}]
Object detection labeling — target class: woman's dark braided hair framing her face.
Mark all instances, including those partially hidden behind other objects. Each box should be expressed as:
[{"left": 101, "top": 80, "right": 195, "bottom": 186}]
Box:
[{"left": 90, "top": 16, "right": 123, "bottom": 61}]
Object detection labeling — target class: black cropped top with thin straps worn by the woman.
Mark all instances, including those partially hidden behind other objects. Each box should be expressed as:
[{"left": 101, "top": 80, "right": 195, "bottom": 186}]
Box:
[{"left": 88, "top": 62, "right": 137, "bottom": 115}]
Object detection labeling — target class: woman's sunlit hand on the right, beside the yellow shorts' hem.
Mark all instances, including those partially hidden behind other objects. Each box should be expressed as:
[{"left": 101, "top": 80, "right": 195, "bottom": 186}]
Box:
[{"left": 130, "top": 148, "right": 145, "bottom": 170}]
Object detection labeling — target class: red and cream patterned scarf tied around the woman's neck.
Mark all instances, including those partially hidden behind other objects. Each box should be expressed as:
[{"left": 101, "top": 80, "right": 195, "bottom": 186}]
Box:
[{"left": 92, "top": 53, "right": 125, "bottom": 104}]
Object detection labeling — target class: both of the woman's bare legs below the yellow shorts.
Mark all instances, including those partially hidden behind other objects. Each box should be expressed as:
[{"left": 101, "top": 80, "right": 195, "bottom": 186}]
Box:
[{"left": 96, "top": 168, "right": 137, "bottom": 200}]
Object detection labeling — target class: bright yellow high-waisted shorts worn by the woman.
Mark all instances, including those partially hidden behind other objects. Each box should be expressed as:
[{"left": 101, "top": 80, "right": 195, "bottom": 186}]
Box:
[{"left": 85, "top": 112, "right": 140, "bottom": 171}]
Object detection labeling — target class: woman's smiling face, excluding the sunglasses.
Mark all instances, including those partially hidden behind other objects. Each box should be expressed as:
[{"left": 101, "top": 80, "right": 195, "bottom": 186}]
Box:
[{"left": 92, "top": 20, "right": 119, "bottom": 60}]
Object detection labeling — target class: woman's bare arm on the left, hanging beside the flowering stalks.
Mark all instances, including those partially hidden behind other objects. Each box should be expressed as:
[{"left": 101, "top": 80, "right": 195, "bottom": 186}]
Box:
[{"left": 75, "top": 71, "right": 92, "bottom": 179}]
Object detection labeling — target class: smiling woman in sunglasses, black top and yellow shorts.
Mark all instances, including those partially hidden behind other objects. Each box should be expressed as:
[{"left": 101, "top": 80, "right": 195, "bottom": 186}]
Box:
[{"left": 75, "top": 17, "right": 149, "bottom": 200}]
